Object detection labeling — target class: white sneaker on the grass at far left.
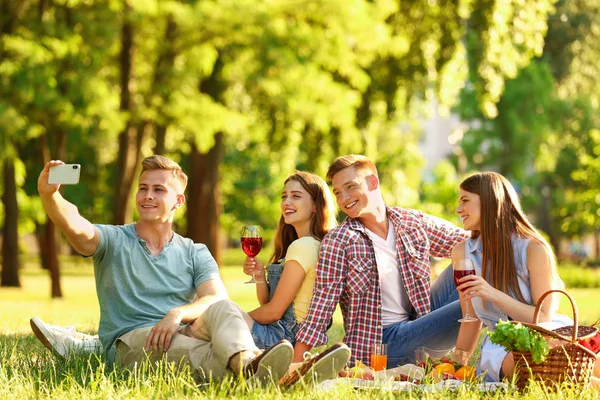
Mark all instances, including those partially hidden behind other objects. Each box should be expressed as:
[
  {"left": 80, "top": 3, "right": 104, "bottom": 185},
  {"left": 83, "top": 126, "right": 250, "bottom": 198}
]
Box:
[{"left": 29, "top": 317, "right": 102, "bottom": 358}]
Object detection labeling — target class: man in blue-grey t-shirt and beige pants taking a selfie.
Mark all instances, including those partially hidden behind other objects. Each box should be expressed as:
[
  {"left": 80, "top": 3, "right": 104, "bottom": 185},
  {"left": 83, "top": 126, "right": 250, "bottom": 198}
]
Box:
[{"left": 32, "top": 156, "right": 293, "bottom": 382}]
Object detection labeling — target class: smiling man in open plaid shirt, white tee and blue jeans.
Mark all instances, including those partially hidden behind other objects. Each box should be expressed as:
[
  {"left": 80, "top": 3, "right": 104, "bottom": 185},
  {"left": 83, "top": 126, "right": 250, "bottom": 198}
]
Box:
[{"left": 294, "top": 155, "right": 469, "bottom": 368}]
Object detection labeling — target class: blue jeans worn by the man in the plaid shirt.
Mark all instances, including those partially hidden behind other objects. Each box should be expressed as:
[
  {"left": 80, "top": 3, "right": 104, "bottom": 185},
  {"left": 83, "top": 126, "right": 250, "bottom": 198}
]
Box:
[{"left": 383, "top": 266, "right": 462, "bottom": 368}]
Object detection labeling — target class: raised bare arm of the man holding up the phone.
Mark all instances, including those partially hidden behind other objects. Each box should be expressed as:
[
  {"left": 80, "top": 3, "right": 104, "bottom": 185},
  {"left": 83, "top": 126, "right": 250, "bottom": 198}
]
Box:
[{"left": 38, "top": 160, "right": 100, "bottom": 256}]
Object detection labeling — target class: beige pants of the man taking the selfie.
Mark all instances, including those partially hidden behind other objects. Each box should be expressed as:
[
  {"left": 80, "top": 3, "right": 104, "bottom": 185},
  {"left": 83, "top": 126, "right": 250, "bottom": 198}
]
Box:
[{"left": 116, "top": 300, "right": 258, "bottom": 380}]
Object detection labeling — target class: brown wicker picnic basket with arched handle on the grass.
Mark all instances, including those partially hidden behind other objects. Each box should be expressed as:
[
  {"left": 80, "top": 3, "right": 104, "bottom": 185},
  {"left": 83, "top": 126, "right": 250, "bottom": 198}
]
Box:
[{"left": 513, "top": 290, "right": 598, "bottom": 390}]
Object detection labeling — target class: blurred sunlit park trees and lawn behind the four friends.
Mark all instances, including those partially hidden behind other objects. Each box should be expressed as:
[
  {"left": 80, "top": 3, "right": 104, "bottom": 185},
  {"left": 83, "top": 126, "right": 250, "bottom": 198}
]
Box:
[{"left": 0, "top": 0, "right": 600, "bottom": 393}]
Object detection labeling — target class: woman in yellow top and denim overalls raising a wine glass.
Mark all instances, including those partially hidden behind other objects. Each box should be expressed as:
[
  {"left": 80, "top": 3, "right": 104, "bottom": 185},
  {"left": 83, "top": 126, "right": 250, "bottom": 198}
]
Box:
[{"left": 244, "top": 172, "right": 335, "bottom": 348}]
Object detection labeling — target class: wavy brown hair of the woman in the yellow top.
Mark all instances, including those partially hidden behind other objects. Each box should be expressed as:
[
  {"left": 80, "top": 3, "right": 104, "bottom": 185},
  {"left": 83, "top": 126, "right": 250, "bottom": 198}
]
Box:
[{"left": 269, "top": 171, "right": 336, "bottom": 263}]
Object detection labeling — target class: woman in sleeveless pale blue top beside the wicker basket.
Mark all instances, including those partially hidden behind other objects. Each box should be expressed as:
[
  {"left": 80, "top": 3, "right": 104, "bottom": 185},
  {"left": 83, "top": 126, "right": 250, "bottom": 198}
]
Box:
[{"left": 452, "top": 172, "right": 569, "bottom": 381}]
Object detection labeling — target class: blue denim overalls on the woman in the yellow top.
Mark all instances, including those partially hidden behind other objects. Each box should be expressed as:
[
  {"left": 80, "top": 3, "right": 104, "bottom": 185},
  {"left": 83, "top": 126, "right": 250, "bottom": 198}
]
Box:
[{"left": 252, "top": 263, "right": 298, "bottom": 349}]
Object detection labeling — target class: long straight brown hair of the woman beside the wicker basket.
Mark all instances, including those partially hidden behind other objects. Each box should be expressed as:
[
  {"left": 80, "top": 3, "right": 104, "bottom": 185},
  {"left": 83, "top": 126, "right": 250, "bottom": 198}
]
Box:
[{"left": 460, "top": 172, "right": 556, "bottom": 303}]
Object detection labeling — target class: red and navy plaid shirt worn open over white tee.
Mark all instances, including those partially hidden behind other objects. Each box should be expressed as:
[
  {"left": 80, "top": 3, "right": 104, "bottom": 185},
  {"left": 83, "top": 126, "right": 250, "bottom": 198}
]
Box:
[{"left": 296, "top": 208, "right": 469, "bottom": 364}]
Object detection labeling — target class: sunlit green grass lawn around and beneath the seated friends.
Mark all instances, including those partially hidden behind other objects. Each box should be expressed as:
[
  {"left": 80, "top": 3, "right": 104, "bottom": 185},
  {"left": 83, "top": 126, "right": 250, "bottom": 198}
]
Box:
[{"left": 0, "top": 251, "right": 600, "bottom": 400}]
